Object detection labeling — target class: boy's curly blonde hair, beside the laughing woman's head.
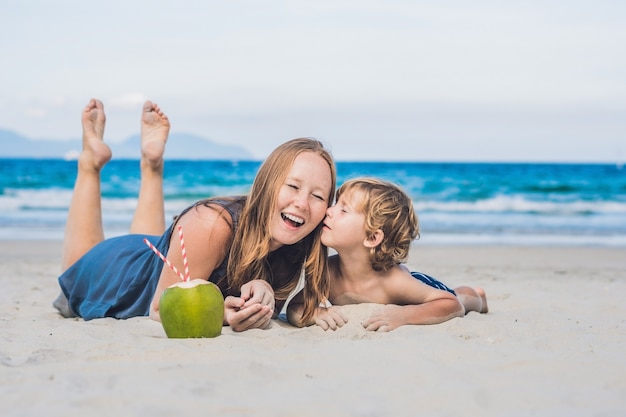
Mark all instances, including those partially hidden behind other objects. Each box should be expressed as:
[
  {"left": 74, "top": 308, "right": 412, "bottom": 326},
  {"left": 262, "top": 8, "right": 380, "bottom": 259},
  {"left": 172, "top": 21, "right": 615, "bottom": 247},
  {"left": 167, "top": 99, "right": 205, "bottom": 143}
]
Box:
[{"left": 337, "top": 177, "right": 419, "bottom": 271}]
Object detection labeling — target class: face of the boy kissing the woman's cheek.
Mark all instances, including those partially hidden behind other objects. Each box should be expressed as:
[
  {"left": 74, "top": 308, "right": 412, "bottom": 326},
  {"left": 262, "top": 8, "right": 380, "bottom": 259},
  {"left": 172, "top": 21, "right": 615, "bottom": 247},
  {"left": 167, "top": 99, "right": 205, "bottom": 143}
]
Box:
[{"left": 322, "top": 192, "right": 367, "bottom": 252}]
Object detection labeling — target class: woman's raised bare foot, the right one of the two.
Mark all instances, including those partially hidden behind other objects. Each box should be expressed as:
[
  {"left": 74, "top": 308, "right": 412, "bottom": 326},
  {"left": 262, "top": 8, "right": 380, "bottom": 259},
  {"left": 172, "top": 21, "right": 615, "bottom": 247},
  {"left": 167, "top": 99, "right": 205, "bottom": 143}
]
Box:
[{"left": 141, "top": 101, "right": 170, "bottom": 170}]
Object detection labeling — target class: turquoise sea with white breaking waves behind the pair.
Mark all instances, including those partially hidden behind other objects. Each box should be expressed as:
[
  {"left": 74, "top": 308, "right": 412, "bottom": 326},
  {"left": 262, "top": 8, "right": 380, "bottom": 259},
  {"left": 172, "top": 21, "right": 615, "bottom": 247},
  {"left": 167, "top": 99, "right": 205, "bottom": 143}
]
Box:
[{"left": 0, "top": 159, "right": 626, "bottom": 246}]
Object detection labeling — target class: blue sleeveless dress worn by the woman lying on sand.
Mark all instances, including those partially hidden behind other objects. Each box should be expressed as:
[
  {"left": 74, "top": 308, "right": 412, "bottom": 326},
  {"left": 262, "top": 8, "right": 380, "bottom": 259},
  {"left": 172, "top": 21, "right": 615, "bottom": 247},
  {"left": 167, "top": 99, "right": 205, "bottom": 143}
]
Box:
[{"left": 53, "top": 197, "right": 245, "bottom": 320}]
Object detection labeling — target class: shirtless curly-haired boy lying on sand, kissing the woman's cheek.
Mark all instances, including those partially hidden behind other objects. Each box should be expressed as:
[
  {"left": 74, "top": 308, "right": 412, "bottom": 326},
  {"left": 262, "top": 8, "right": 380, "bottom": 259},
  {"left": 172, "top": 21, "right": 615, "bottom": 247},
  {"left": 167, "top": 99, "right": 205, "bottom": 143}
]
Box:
[{"left": 287, "top": 178, "right": 488, "bottom": 331}]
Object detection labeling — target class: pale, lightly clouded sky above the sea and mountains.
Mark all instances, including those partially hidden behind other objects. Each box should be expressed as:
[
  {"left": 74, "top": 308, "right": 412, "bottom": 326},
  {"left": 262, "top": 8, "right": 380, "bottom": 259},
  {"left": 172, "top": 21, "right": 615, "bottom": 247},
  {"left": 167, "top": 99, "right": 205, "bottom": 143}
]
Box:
[{"left": 0, "top": 0, "right": 626, "bottom": 163}]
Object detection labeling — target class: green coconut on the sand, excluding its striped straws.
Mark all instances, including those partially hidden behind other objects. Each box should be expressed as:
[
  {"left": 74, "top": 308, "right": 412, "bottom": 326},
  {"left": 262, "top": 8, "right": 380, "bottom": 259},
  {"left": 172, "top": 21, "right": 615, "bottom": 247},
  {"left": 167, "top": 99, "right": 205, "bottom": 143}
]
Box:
[{"left": 159, "top": 279, "right": 224, "bottom": 338}]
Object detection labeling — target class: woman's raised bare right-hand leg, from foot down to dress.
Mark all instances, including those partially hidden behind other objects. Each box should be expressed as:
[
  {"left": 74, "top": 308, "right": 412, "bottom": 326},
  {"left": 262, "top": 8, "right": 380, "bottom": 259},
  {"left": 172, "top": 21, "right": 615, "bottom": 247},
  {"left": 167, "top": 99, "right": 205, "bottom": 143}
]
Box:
[{"left": 130, "top": 101, "right": 170, "bottom": 235}]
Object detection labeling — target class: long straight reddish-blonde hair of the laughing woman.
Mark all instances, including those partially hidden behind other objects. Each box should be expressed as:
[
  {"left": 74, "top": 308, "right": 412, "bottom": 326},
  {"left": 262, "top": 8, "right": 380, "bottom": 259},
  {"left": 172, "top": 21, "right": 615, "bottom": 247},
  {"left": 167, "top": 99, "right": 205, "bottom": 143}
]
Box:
[{"left": 228, "top": 138, "right": 337, "bottom": 320}]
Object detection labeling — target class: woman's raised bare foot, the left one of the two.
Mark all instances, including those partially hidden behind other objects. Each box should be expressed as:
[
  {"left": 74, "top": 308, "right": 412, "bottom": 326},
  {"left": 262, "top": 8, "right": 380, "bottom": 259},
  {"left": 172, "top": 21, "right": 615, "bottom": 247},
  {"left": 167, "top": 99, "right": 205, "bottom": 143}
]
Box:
[{"left": 78, "top": 98, "right": 111, "bottom": 171}]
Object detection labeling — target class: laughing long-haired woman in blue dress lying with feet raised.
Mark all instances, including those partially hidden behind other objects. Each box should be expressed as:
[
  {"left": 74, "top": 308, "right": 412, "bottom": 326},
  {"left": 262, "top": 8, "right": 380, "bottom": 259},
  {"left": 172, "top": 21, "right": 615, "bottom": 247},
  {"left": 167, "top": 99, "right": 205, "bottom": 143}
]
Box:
[{"left": 54, "top": 99, "right": 336, "bottom": 331}]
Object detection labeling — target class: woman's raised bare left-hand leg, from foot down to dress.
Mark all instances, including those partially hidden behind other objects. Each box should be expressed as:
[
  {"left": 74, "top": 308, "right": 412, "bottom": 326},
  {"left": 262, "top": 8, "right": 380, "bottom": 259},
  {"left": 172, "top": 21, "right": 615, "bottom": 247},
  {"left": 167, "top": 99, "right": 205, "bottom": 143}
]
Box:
[{"left": 61, "top": 99, "right": 111, "bottom": 271}]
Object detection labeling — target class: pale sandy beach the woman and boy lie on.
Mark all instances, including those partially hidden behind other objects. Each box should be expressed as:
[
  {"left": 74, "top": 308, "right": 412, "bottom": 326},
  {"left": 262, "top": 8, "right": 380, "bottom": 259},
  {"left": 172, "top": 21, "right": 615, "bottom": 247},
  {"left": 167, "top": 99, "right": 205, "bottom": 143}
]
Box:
[{"left": 0, "top": 241, "right": 626, "bottom": 417}]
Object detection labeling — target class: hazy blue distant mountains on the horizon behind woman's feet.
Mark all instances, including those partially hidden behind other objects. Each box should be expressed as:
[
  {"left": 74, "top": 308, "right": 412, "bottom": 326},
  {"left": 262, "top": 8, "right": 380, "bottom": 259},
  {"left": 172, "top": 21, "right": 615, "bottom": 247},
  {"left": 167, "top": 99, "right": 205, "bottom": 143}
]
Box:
[{"left": 0, "top": 129, "right": 254, "bottom": 161}]
